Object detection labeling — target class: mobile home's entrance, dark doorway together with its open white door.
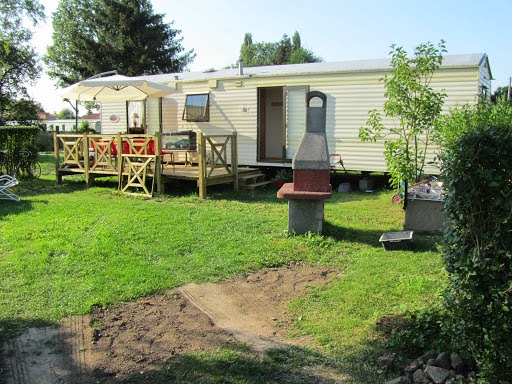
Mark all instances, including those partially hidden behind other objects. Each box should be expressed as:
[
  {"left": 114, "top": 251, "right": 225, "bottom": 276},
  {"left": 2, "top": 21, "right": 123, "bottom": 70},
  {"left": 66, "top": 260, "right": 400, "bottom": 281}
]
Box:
[{"left": 258, "top": 86, "right": 309, "bottom": 163}]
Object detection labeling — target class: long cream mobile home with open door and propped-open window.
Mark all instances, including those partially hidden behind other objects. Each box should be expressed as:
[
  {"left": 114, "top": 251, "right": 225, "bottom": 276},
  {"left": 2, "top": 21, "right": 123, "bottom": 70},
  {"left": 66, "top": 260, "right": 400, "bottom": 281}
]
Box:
[{"left": 97, "top": 53, "right": 492, "bottom": 172}]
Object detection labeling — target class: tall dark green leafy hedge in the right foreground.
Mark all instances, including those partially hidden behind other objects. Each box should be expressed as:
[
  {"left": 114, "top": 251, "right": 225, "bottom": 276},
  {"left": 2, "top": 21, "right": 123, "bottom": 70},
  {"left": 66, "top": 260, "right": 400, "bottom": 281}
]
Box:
[{"left": 443, "top": 125, "right": 512, "bottom": 383}]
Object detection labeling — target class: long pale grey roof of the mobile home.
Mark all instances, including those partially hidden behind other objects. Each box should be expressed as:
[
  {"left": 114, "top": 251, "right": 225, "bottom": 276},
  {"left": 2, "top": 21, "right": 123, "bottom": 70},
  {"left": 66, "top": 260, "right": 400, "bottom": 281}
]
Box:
[{"left": 141, "top": 53, "right": 487, "bottom": 83}]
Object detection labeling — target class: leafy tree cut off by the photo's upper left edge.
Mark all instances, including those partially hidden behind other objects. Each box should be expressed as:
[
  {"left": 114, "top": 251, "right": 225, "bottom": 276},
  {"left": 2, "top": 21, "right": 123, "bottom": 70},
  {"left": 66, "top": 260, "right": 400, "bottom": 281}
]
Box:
[{"left": 0, "top": 0, "right": 44, "bottom": 115}]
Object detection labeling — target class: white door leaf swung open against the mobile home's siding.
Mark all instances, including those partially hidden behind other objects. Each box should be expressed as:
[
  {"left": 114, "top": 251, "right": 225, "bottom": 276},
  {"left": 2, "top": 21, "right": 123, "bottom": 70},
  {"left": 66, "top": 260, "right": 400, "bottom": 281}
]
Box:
[{"left": 283, "top": 86, "right": 309, "bottom": 160}]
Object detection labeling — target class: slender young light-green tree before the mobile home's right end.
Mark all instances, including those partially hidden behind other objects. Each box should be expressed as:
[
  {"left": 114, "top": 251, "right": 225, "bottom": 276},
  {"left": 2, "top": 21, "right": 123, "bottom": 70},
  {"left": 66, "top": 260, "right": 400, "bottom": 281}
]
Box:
[{"left": 359, "top": 40, "right": 446, "bottom": 187}]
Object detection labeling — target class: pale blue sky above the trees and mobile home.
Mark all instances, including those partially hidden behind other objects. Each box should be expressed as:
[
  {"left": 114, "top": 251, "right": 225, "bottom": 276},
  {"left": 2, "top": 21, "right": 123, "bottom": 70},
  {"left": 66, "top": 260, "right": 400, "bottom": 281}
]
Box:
[{"left": 31, "top": 0, "right": 512, "bottom": 112}]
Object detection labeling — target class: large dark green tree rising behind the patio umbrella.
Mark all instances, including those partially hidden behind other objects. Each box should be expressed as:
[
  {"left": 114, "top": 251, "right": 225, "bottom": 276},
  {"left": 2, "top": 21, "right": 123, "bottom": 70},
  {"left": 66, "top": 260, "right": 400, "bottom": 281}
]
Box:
[{"left": 43, "top": 0, "right": 195, "bottom": 86}]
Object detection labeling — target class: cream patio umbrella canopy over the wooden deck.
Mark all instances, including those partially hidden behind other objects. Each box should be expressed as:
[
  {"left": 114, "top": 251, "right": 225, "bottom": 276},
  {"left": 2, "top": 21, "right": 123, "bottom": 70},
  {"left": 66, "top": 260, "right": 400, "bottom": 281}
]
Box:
[{"left": 59, "top": 75, "right": 176, "bottom": 102}]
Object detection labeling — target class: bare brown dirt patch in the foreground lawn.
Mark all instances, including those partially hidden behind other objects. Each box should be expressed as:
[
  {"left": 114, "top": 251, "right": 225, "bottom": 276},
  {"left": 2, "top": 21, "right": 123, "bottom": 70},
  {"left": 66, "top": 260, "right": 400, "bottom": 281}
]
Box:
[{"left": 4, "top": 267, "right": 339, "bottom": 384}]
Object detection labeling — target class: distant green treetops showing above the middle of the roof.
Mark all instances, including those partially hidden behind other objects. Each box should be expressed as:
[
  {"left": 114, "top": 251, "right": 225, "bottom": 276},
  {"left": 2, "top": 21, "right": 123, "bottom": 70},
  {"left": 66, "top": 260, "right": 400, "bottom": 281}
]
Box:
[{"left": 240, "top": 31, "right": 322, "bottom": 67}]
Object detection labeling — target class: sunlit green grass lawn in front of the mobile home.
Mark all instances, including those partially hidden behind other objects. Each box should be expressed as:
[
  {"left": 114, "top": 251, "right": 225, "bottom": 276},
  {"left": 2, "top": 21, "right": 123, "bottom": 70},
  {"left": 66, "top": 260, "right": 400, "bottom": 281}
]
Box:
[{"left": 0, "top": 157, "right": 444, "bottom": 383}]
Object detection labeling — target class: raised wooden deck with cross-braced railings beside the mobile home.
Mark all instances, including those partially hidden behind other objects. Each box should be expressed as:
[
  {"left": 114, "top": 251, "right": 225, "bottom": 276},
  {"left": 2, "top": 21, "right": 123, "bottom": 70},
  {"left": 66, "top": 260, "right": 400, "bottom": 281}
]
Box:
[{"left": 54, "top": 133, "right": 248, "bottom": 199}]
